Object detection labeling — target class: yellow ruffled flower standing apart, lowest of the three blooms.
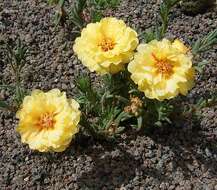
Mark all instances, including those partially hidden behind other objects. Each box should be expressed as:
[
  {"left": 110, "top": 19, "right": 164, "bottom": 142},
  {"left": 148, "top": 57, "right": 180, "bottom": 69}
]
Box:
[{"left": 16, "top": 89, "right": 80, "bottom": 152}]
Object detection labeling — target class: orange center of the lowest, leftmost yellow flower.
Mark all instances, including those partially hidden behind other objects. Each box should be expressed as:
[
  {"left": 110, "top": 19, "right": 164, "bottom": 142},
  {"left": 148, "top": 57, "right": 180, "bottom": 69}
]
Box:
[{"left": 37, "top": 113, "right": 56, "bottom": 130}]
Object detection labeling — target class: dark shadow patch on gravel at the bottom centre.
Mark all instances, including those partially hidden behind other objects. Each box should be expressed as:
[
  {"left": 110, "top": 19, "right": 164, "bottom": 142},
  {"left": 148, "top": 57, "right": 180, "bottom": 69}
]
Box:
[{"left": 78, "top": 142, "right": 173, "bottom": 189}]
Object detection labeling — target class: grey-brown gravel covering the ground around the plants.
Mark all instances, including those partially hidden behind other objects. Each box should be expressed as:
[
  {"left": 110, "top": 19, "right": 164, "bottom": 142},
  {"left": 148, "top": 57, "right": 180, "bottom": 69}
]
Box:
[{"left": 0, "top": 0, "right": 217, "bottom": 190}]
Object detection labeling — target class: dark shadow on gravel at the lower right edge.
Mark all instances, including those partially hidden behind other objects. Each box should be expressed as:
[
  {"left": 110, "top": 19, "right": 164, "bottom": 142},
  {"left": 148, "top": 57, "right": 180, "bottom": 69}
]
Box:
[{"left": 151, "top": 124, "right": 217, "bottom": 179}]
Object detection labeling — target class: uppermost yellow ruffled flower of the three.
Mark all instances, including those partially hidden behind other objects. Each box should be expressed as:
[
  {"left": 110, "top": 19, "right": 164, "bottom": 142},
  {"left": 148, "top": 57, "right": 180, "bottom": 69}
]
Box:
[{"left": 73, "top": 17, "right": 138, "bottom": 74}]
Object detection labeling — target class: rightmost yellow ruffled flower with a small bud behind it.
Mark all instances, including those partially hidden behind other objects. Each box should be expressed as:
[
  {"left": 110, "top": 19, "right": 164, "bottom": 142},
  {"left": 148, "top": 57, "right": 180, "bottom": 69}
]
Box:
[{"left": 128, "top": 39, "right": 194, "bottom": 101}]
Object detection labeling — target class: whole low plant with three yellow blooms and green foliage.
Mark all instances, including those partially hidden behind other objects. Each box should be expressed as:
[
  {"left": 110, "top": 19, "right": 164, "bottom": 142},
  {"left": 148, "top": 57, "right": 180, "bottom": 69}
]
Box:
[{"left": 0, "top": 0, "right": 217, "bottom": 152}]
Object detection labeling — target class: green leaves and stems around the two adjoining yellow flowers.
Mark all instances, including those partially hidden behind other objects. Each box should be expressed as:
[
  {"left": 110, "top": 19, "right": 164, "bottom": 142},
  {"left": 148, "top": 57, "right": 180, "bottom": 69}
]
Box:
[{"left": 72, "top": 0, "right": 217, "bottom": 141}]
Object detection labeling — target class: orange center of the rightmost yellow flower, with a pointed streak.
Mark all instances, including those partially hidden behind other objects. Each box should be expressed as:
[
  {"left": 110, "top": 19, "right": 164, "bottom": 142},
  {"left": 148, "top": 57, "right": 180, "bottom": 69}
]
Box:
[{"left": 152, "top": 53, "right": 173, "bottom": 76}]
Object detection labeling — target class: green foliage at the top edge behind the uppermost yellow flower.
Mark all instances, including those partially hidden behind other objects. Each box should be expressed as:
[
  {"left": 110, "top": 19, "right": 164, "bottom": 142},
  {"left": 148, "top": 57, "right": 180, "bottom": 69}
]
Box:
[{"left": 48, "top": 0, "right": 120, "bottom": 29}]
